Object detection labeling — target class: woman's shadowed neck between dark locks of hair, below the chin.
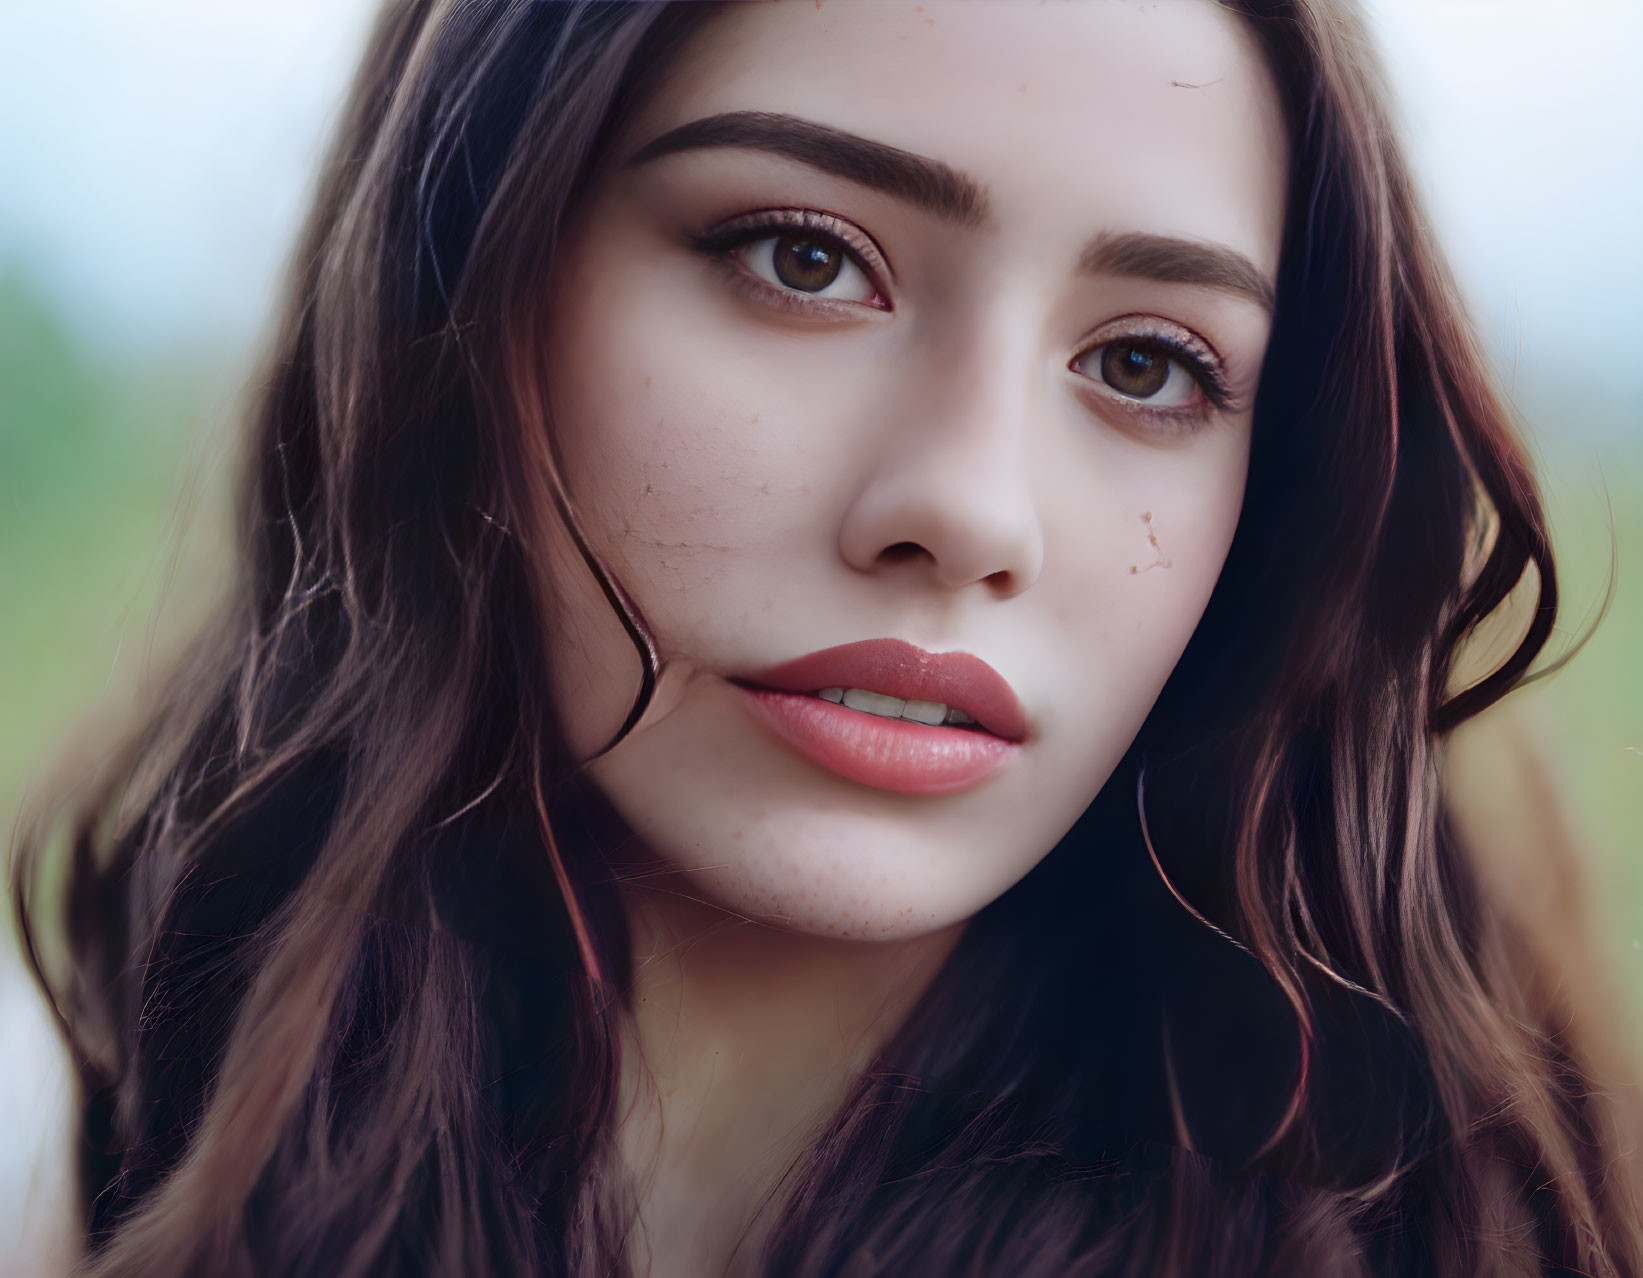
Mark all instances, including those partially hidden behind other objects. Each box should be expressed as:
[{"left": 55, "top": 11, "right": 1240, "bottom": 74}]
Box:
[{"left": 616, "top": 880, "right": 961, "bottom": 1278}]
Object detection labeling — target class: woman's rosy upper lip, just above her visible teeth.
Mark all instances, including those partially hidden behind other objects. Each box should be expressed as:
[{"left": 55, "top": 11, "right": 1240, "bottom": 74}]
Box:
[{"left": 741, "top": 639, "right": 1027, "bottom": 741}]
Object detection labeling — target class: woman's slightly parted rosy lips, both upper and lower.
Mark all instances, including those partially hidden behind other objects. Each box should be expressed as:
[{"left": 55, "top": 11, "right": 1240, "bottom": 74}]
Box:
[{"left": 731, "top": 639, "right": 1027, "bottom": 795}]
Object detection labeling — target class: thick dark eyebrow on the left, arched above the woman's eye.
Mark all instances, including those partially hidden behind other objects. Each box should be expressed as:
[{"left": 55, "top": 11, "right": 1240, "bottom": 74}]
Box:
[{"left": 626, "top": 112, "right": 989, "bottom": 227}]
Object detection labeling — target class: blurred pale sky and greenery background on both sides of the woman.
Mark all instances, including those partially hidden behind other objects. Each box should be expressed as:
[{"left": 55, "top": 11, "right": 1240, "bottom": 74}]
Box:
[{"left": 0, "top": 0, "right": 1643, "bottom": 1273}]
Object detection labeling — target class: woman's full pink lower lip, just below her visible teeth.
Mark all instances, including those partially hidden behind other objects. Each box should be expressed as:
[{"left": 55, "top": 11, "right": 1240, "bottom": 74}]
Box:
[{"left": 734, "top": 683, "right": 1019, "bottom": 795}]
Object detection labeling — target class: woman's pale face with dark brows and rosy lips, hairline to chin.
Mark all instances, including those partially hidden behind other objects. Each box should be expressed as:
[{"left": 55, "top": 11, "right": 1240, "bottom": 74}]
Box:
[{"left": 547, "top": 0, "right": 1286, "bottom": 938}]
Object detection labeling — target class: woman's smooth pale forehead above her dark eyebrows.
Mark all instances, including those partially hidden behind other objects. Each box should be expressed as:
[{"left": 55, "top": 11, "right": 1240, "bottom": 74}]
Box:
[{"left": 634, "top": 0, "right": 1286, "bottom": 276}]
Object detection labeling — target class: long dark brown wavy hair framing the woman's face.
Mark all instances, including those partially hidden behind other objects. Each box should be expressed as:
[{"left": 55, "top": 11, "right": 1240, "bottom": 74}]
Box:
[{"left": 13, "top": 0, "right": 1643, "bottom": 1278}]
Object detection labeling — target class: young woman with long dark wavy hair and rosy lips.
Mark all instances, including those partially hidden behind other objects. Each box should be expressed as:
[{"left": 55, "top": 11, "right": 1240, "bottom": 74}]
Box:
[{"left": 20, "top": 0, "right": 1643, "bottom": 1278}]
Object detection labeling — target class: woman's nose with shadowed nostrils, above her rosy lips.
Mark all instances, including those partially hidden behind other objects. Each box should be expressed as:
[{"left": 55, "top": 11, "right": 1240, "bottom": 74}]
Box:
[{"left": 840, "top": 348, "right": 1043, "bottom": 598}]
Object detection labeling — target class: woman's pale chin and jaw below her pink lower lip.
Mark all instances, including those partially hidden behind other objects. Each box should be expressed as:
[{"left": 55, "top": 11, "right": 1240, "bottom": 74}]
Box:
[{"left": 588, "top": 673, "right": 1121, "bottom": 941}]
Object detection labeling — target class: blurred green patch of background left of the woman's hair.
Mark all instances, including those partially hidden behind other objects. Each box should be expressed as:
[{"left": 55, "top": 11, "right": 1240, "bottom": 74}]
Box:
[{"left": 0, "top": 269, "right": 232, "bottom": 813}]
